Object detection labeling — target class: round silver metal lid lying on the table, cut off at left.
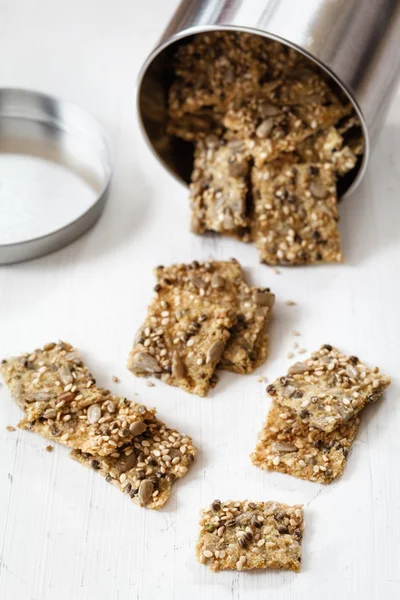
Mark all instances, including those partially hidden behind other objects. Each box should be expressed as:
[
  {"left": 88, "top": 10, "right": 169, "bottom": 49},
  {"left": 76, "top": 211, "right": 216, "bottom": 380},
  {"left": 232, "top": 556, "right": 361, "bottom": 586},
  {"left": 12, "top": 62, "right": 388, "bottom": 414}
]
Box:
[{"left": 0, "top": 89, "right": 111, "bottom": 264}]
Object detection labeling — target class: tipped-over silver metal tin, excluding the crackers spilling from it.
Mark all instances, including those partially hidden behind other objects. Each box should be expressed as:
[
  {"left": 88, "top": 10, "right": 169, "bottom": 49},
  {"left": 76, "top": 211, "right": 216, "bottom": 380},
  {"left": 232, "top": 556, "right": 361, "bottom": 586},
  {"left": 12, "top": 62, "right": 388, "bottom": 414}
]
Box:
[{"left": 137, "top": 0, "right": 400, "bottom": 194}]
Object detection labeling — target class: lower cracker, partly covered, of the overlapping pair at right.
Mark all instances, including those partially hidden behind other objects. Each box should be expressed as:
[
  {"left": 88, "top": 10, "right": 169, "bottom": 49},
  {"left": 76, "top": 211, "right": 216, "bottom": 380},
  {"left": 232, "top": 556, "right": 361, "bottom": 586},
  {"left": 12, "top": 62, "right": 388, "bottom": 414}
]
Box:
[{"left": 251, "top": 404, "right": 360, "bottom": 483}]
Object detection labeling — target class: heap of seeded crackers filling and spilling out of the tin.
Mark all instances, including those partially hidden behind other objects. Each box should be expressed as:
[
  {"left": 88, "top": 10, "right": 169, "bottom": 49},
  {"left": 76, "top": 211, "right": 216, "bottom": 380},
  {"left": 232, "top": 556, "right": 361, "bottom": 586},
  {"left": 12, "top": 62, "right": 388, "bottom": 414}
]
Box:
[{"left": 168, "top": 32, "right": 363, "bottom": 265}]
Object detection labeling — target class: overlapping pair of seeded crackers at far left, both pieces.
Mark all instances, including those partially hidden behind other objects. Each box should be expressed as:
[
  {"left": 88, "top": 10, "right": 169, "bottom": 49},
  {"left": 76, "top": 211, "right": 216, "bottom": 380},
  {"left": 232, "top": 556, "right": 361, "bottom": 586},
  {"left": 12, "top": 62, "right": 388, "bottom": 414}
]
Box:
[{"left": 1, "top": 342, "right": 196, "bottom": 509}]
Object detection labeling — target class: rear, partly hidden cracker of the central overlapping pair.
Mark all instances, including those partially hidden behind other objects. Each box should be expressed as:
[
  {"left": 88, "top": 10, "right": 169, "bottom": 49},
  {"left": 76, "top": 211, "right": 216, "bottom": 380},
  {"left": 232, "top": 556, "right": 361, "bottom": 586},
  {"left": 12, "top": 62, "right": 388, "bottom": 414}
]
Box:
[{"left": 156, "top": 259, "right": 275, "bottom": 374}]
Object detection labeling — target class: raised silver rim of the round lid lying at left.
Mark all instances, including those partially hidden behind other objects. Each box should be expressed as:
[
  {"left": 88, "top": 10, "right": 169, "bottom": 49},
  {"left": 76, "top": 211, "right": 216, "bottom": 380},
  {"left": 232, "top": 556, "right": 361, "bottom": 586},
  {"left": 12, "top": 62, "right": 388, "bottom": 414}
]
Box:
[{"left": 0, "top": 88, "right": 113, "bottom": 265}]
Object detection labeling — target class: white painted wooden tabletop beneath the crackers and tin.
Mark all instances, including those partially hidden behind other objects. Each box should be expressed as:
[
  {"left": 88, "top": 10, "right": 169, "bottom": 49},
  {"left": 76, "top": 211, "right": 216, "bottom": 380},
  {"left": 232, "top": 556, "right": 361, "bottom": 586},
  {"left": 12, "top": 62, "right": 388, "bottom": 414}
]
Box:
[{"left": 0, "top": 0, "right": 400, "bottom": 600}]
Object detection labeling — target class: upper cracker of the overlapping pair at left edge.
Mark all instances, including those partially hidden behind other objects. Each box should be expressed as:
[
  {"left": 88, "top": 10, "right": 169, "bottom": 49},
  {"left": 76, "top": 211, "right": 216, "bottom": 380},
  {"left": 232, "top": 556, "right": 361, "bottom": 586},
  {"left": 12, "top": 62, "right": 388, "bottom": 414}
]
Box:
[{"left": 1, "top": 342, "right": 155, "bottom": 456}]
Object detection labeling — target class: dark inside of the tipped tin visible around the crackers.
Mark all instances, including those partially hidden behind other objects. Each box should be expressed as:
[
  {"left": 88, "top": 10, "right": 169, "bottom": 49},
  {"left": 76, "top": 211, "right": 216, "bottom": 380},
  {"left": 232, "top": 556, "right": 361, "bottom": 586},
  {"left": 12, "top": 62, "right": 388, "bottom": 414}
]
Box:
[{"left": 137, "top": 27, "right": 367, "bottom": 197}]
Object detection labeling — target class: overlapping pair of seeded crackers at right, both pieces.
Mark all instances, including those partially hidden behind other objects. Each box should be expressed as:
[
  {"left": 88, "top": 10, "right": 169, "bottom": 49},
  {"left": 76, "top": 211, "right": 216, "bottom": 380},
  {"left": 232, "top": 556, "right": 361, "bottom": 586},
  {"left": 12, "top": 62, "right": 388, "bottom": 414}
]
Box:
[{"left": 251, "top": 344, "right": 390, "bottom": 483}]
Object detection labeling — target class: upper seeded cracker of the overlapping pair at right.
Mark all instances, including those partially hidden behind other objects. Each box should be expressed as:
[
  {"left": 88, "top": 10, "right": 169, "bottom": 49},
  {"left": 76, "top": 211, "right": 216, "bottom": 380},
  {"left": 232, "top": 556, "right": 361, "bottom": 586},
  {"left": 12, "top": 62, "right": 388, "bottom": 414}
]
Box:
[{"left": 267, "top": 344, "right": 390, "bottom": 433}]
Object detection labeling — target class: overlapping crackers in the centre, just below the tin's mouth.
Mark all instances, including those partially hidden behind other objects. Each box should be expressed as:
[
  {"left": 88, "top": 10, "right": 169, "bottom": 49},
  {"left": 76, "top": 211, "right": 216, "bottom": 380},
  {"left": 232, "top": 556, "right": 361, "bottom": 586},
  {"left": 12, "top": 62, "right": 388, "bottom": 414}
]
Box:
[{"left": 128, "top": 259, "right": 275, "bottom": 396}]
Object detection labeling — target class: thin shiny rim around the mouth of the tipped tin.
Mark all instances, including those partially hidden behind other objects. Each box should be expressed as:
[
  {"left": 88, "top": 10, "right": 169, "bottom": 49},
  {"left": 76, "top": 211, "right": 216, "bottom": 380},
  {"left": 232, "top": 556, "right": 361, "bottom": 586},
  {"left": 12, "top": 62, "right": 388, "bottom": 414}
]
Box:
[{"left": 136, "top": 25, "right": 370, "bottom": 198}]
